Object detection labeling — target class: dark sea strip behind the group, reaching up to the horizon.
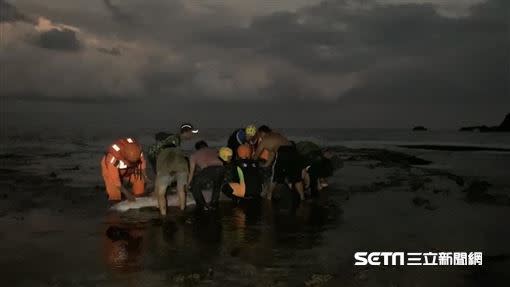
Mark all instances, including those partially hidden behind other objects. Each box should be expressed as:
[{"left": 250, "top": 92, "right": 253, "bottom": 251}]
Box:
[{"left": 0, "top": 124, "right": 510, "bottom": 186}]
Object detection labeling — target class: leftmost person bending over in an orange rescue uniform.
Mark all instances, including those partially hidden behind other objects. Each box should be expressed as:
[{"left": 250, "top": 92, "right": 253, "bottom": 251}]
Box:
[{"left": 101, "top": 138, "right": 147, "bottom": 201}]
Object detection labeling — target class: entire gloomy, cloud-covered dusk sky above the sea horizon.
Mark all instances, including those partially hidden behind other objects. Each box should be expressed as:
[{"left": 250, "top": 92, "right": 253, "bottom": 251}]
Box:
[{"left": 0, "top": 0, "right": 510, "bottom": 128}]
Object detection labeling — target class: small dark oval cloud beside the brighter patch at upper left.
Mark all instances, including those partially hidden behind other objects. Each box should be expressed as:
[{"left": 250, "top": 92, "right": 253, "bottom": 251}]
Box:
[{"left": 38, "top": 28, "right": 81, "bottom": 51}]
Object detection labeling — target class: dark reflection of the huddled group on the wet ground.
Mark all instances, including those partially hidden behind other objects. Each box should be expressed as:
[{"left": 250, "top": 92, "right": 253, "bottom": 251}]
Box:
[{"left": 104, "top": 195, "right": 341, "bottom": 280}]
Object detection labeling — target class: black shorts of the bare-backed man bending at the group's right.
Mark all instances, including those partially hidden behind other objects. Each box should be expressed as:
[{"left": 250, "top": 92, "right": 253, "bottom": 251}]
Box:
[{"left": 271, "top": 146, "right": 303, "bottom": 184}]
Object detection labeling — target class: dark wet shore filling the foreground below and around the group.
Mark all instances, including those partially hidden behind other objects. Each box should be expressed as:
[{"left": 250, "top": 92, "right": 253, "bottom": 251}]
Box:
[{"left": 0, "top": 148, "right": 510, "bottom": 286}]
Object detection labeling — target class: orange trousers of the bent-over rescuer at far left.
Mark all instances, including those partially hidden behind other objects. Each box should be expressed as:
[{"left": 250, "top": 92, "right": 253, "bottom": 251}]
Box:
[{"left": 101, "top": 154, "right": 145, "bottom": 200}]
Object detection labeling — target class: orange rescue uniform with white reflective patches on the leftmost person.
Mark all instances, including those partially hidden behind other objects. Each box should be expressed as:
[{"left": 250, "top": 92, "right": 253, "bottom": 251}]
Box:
[{"left": 101, "top": 138, "right": 147, "bottom": 200}]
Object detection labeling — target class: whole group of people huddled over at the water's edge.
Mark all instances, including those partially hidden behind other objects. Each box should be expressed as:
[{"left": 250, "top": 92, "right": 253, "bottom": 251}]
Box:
[{"left": 101, "top": 123, "right": 333, "bottom": 215}]
